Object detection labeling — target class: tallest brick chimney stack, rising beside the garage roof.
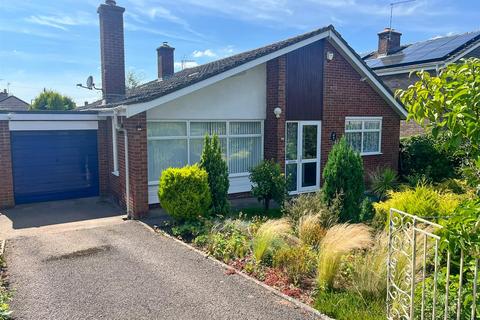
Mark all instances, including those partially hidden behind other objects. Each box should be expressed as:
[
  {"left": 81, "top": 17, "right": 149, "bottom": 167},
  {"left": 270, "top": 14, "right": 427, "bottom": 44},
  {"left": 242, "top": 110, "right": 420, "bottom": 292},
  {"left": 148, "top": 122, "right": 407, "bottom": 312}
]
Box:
[{"left": 97, "top": 0, "right": 125, "bottom": 103}]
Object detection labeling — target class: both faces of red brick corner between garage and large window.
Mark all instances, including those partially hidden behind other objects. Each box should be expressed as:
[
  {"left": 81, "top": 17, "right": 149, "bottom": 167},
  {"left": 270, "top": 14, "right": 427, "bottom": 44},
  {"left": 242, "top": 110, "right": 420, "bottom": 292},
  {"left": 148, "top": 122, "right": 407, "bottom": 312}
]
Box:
[{"left": 104, "top": 112, "right": 148, "bottom": 218}]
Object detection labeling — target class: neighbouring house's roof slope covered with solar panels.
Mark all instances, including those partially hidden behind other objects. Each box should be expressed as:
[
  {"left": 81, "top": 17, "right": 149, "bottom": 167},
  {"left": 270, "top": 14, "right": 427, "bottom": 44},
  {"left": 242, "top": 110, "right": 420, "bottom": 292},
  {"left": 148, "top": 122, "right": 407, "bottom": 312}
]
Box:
[{"left": 362, "top": 31, "right": 480, "bottom": 69}]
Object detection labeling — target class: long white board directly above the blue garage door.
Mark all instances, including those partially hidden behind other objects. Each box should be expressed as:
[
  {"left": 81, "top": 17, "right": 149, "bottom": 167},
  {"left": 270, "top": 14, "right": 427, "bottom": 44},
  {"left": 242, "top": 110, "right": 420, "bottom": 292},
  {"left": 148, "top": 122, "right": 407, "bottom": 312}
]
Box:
[{"left": 9, "top": 120, "right": 98, "bottom": 131}]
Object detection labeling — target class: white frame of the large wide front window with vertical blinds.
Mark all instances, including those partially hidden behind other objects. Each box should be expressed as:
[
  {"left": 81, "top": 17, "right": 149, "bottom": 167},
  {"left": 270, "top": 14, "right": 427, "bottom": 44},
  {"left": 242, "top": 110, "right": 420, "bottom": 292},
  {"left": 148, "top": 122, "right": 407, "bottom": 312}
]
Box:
[{"left": 147, "top": 119, "right": 265, "bottom": 186}]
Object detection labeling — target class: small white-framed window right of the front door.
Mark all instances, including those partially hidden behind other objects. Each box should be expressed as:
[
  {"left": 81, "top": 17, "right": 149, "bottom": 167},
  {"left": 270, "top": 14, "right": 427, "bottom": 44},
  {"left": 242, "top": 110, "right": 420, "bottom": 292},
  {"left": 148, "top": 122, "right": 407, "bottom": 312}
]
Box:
[{"left": 345, "top": 117, "right": 382, "bottom": 155}]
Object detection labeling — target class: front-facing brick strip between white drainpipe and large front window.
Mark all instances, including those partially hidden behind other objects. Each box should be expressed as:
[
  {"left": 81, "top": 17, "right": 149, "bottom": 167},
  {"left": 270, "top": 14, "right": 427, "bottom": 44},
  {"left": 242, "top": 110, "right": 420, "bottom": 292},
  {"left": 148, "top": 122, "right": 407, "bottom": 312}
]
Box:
[{"left": 124, "top": 112, "right": 148, "bottom": 218}]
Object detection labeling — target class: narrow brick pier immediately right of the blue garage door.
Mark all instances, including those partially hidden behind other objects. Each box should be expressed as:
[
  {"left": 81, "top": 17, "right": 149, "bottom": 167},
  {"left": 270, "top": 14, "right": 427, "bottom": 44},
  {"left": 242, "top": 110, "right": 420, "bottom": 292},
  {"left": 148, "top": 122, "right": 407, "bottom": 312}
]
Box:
[{"left": 97, "top": 118, "right": 111, "bottom": 197}]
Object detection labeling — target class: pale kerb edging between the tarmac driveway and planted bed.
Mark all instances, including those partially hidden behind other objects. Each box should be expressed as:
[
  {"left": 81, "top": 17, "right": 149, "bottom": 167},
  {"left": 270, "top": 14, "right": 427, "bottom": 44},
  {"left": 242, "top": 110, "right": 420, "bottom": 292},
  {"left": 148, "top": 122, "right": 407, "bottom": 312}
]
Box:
[{"left": 136, "top": 220, "right": 335, "bottom": 320}]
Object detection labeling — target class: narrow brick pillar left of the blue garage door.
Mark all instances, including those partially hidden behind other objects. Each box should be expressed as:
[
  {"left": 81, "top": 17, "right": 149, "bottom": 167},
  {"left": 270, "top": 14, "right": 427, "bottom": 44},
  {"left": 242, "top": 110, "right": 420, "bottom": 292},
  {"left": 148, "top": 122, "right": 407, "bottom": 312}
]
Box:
[{"left": 0, "top": 121, "right": 15, "bottom": 208}]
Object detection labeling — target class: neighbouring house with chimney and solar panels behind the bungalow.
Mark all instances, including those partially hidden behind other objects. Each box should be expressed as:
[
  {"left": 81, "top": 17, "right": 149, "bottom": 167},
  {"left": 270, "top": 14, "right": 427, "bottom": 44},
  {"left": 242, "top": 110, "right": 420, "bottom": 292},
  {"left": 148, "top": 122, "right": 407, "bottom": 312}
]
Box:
[{"left": 362, "top": 28, "right": 480, "bottom": 137}]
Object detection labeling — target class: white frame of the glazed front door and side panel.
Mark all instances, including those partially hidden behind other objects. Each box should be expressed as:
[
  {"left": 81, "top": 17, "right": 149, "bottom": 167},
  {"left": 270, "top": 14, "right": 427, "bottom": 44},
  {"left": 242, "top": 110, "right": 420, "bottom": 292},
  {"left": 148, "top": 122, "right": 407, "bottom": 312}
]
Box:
[{"left": 285, "top": 121, "right": 322, "bottom": 195}]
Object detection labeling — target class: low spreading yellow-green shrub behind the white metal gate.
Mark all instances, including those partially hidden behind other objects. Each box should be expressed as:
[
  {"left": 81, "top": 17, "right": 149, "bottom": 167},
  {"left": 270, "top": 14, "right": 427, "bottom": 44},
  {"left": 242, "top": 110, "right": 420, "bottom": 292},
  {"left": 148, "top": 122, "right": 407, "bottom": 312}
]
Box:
[{"left": 373, "top": 185, "right": 468, "bottom": 227}]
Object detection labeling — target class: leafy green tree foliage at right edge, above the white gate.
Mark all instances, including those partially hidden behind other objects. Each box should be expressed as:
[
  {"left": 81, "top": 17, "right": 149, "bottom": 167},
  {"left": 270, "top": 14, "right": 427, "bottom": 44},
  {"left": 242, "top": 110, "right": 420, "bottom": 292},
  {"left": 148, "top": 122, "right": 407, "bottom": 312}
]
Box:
[{"left": 397, "top": 58, "right": 480, "bottom": 185}]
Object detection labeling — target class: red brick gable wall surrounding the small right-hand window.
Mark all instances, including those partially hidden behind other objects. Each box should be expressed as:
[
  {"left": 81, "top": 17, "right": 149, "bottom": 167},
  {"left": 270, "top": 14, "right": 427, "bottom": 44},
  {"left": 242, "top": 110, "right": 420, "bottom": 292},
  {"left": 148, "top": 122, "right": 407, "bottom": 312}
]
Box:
[{"left": 321, "top": 42, "right": 400, "bottom": 176}]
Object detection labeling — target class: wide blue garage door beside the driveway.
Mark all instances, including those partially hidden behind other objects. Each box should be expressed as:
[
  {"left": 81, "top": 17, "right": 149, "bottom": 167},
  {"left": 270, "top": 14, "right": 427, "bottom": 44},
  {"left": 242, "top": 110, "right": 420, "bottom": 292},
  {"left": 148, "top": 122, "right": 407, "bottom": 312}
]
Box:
[{"left": 11, "top": 130, "right": 98, "bottom": 204}]
